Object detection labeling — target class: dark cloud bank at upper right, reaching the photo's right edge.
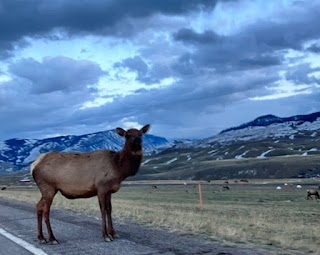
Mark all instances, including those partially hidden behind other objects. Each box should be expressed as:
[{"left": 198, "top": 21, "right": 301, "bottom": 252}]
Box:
[{"left": 173, "top": 3, "right": 320, "bottom": 74}]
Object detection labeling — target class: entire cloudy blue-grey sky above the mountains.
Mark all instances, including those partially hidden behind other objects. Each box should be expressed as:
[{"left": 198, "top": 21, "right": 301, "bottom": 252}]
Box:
[{"left": 0, "top": 0, "right": 320, "bottom": 140}]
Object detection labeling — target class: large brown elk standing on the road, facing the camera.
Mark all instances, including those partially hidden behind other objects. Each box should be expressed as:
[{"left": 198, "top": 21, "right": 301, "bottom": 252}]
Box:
[{"left": 30, "top": 125, "right": 150, "bottom": 244}]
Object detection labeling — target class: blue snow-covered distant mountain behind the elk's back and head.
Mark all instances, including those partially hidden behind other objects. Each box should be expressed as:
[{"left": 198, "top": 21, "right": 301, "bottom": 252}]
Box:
[{"left": 0, "top": 130, "right": 171, "bottom": 171}]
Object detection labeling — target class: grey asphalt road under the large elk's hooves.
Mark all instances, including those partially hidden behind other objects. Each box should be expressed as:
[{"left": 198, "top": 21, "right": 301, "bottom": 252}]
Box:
[{"left": 0, "top": 199, "right": 274, "bottom": 255}]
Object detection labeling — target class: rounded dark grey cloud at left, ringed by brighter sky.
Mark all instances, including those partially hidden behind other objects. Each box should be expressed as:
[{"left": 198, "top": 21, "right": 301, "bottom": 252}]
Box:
[{"left": 9, "top": 57, "right": 105, "bottom": 94}]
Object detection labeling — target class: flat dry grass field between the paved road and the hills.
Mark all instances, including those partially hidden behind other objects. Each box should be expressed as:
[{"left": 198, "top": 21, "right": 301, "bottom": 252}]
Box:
[{"left": 0, "top": 179, "right": 320, "bottom": 254}]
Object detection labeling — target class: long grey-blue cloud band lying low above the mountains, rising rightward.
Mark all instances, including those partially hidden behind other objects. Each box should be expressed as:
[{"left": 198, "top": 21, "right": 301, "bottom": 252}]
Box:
[{"left": 0, "top": 57, "right": 278, "bottom": 138}]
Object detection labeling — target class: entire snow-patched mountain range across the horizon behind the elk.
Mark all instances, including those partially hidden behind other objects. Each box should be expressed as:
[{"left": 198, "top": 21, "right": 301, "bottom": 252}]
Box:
[{"left": 0, "top": 112, "right": 320, "bottom": 180}]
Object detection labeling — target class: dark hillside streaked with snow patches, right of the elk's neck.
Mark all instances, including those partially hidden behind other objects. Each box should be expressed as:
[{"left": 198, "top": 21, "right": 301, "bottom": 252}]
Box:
[{"left": 139, "top": 112, "right": 320, "bottom": 180}]
